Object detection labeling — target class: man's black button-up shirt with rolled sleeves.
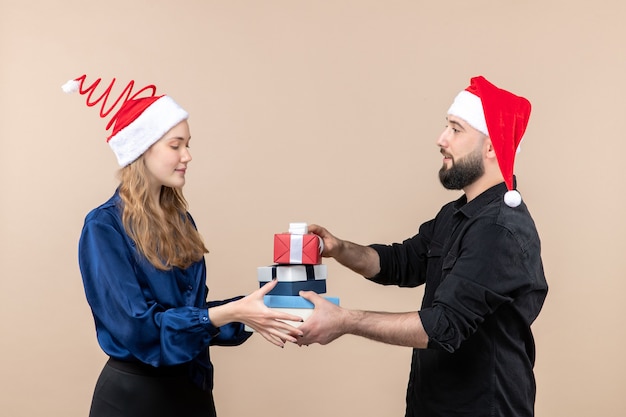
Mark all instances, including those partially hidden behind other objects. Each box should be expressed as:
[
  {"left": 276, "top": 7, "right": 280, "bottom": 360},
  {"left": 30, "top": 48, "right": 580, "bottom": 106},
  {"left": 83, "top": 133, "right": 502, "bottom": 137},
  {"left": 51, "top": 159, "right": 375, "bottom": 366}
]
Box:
[{"left": 371, "top": 183, "right": 548, "bottom": 417}]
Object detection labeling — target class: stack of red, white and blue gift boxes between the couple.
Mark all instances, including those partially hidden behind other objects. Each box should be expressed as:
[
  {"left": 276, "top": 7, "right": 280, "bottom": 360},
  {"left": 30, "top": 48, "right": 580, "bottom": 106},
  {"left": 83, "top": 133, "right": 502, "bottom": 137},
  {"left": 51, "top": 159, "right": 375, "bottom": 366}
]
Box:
[{"left": 252, "top": 223, "right": 339, "bottom": 326}]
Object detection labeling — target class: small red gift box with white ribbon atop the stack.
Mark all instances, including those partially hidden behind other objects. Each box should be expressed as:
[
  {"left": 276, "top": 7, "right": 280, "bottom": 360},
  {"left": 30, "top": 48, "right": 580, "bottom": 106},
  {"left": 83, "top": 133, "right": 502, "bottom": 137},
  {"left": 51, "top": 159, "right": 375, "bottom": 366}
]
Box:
[{"left": 274, "top": 233, "right": 322, "bottom": 265}]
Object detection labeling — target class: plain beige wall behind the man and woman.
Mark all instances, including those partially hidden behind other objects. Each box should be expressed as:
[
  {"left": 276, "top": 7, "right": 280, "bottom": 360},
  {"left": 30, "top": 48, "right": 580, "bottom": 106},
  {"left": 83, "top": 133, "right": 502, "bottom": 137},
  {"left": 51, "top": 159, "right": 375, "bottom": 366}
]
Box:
[{"left": 0, "top": 0, "right": 626, "bottom": 417}]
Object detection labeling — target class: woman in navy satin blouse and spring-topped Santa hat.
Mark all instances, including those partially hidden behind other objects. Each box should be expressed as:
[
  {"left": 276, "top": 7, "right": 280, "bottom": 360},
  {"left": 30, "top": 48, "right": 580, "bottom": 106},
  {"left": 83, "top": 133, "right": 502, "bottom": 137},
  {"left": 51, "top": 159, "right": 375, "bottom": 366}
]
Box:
[{"left": 67, "top": 76, "right": 301, "bottom": 417}]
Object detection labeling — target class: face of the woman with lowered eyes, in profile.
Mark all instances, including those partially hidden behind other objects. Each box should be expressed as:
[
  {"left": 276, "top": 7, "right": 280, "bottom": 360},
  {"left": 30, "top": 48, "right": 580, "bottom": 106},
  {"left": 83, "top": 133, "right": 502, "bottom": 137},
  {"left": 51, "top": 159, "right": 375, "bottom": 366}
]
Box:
[{"left": 143, "top": 120, "right": 191, "bottom": 191}]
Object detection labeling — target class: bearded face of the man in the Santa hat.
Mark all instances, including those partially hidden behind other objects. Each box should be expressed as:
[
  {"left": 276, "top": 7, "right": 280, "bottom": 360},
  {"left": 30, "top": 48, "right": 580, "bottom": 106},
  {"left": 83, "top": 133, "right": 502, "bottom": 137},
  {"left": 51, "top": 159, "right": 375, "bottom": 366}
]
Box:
[{"left": 437, "top": 116, "right": 486, "bottom": 190}]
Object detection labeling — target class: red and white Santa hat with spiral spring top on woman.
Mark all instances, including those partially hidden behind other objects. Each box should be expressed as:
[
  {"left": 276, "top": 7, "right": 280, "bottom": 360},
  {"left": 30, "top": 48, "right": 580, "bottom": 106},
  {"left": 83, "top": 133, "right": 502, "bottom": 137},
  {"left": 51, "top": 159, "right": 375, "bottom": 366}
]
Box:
[{"left": 61, "top": 75, "right": 189, "bottom": 167}]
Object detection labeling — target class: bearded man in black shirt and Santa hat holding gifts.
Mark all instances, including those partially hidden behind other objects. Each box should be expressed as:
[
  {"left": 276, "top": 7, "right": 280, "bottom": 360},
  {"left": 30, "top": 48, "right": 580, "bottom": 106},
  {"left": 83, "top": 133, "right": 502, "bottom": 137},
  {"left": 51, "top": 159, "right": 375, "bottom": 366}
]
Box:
[{"left": 299, "top": 77, "right": 548, "bottom": 417}]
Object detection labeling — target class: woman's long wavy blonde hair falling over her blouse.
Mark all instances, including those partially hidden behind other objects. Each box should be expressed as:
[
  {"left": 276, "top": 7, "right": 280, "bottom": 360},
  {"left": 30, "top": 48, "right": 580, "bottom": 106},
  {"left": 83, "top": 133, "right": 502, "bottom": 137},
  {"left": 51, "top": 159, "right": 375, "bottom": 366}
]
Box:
[{"left": 119, "top": 155, "right": 208, "bottom": 271}]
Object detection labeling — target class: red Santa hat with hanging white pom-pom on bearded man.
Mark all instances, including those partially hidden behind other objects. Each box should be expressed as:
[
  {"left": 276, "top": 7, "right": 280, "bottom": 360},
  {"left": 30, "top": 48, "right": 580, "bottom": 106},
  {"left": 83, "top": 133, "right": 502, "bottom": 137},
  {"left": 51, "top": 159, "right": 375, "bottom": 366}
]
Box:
[{"left": 448, "top": 76, "right": 531, "bottom": 207}]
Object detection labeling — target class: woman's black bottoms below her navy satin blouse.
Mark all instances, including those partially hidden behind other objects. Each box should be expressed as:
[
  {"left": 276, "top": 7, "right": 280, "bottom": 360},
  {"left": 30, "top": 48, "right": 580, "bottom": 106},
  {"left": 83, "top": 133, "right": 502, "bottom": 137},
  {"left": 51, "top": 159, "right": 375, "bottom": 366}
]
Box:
[{"left": 89, "top": 359, "right": 216, "bottom": 417}]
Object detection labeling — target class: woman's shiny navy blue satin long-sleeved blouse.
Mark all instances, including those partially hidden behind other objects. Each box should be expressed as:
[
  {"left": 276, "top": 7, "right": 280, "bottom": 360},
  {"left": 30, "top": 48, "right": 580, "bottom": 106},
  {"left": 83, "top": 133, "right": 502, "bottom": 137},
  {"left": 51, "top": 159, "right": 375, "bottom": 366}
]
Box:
[{"left": 78, "top": 192, "right": 251, "bottom": 389}]
